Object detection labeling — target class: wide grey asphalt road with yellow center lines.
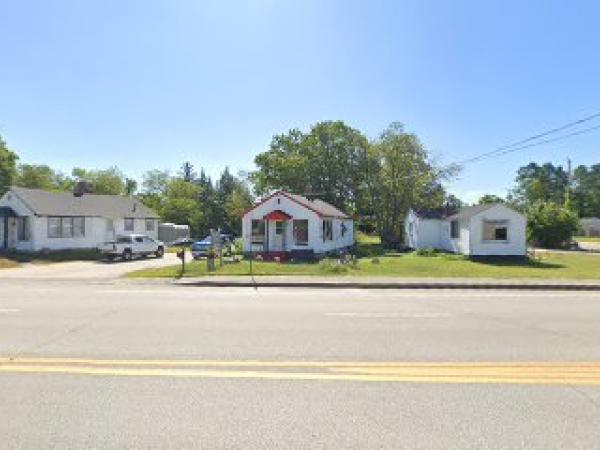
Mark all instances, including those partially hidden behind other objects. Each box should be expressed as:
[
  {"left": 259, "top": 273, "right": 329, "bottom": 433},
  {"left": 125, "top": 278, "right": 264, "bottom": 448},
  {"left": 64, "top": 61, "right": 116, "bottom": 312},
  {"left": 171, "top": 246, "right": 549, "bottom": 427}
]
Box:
[{"left": 0, "top": 279, "right": 600, "bottom": 449}]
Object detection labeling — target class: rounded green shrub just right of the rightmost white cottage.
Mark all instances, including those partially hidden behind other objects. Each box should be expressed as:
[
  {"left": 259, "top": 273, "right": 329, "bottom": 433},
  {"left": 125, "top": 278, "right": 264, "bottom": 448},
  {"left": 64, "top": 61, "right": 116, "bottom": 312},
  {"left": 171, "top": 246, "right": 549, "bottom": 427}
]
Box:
[{"left": 527, "top": 202, "right": 579, "bottom": 248}]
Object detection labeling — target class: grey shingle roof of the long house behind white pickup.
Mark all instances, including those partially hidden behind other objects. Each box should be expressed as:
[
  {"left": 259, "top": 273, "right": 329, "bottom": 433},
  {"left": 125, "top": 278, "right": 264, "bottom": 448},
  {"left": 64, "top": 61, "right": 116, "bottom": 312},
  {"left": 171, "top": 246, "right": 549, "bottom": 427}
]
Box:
[{"left": 10, "top": 187, "right": 158, "bottom": 219}]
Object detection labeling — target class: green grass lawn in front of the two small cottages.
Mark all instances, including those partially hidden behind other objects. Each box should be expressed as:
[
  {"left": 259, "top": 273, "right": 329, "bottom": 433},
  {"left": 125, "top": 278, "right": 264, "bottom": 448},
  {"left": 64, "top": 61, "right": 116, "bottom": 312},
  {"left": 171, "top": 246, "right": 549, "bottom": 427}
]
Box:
[{"left": 128, "top": 253, "right": 600, "bottom": 279}]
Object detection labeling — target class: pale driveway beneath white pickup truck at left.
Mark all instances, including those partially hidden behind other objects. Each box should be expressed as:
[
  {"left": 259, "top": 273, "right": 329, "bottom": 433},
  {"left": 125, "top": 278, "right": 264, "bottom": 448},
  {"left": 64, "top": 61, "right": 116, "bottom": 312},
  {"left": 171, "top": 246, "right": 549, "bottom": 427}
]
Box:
[{"left": 0, "top": 253, "right": 180, "bottom": 281}]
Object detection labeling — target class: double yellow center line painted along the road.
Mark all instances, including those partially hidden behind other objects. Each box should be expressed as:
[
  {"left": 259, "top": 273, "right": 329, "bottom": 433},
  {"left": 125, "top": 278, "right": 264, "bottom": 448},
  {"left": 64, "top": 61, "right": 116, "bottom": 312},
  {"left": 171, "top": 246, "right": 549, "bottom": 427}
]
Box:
[{"left": 0, "top": 358, "right": 600, "bottom": 386}]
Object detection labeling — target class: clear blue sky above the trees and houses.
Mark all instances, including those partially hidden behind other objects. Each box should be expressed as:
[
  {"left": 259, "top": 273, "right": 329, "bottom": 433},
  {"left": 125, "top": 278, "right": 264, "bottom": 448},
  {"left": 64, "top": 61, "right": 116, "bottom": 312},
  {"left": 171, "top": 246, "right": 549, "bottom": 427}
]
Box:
[{"left": 0, "top": 0, "right": 600, "bottom": 200}]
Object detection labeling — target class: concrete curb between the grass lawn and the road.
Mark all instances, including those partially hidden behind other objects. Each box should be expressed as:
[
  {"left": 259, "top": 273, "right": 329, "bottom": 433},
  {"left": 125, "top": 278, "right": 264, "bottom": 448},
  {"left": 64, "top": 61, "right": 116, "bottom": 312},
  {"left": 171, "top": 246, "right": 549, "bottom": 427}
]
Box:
[{"left": 172, "top": 279, "right": 600, "bottom": 291}]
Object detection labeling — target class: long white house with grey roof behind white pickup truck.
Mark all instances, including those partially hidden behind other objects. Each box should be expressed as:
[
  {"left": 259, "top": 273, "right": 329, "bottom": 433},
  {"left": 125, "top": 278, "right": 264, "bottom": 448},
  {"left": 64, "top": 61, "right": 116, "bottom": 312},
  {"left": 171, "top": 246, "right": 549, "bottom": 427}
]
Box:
[{"left": 0, "top": 187, "right": 158, "bottom": 252}]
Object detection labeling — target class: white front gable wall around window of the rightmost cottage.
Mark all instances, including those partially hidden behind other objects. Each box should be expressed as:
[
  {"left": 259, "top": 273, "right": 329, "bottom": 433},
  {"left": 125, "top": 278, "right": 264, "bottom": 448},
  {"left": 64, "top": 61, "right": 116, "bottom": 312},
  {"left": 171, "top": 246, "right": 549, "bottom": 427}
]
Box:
[{"left": 470, "top": 205, "right": 527, "bottom": 256}]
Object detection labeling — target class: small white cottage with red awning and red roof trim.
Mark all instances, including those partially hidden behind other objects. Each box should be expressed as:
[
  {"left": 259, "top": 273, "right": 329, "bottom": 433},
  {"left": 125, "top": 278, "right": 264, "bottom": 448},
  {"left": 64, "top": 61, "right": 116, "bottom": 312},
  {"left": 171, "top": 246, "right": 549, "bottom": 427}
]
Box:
[{"left": 242, "top": 191, "right": 354, "bottom": 258}]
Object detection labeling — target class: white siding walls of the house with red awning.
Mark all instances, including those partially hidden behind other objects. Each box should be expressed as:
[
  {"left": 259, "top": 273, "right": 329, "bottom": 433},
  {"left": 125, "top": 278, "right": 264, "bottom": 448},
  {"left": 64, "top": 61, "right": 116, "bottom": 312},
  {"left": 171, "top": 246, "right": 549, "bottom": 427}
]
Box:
[{"left": 242, "top": 194, "right": 354, "bottom": 253}]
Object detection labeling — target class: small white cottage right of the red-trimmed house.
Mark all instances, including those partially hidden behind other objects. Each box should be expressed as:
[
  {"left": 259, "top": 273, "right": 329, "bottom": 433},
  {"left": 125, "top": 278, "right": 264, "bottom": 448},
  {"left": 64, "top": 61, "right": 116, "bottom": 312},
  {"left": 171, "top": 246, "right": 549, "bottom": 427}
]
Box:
[{"left": 404, "top": 204, "right": 527, "bottom": 256}]
